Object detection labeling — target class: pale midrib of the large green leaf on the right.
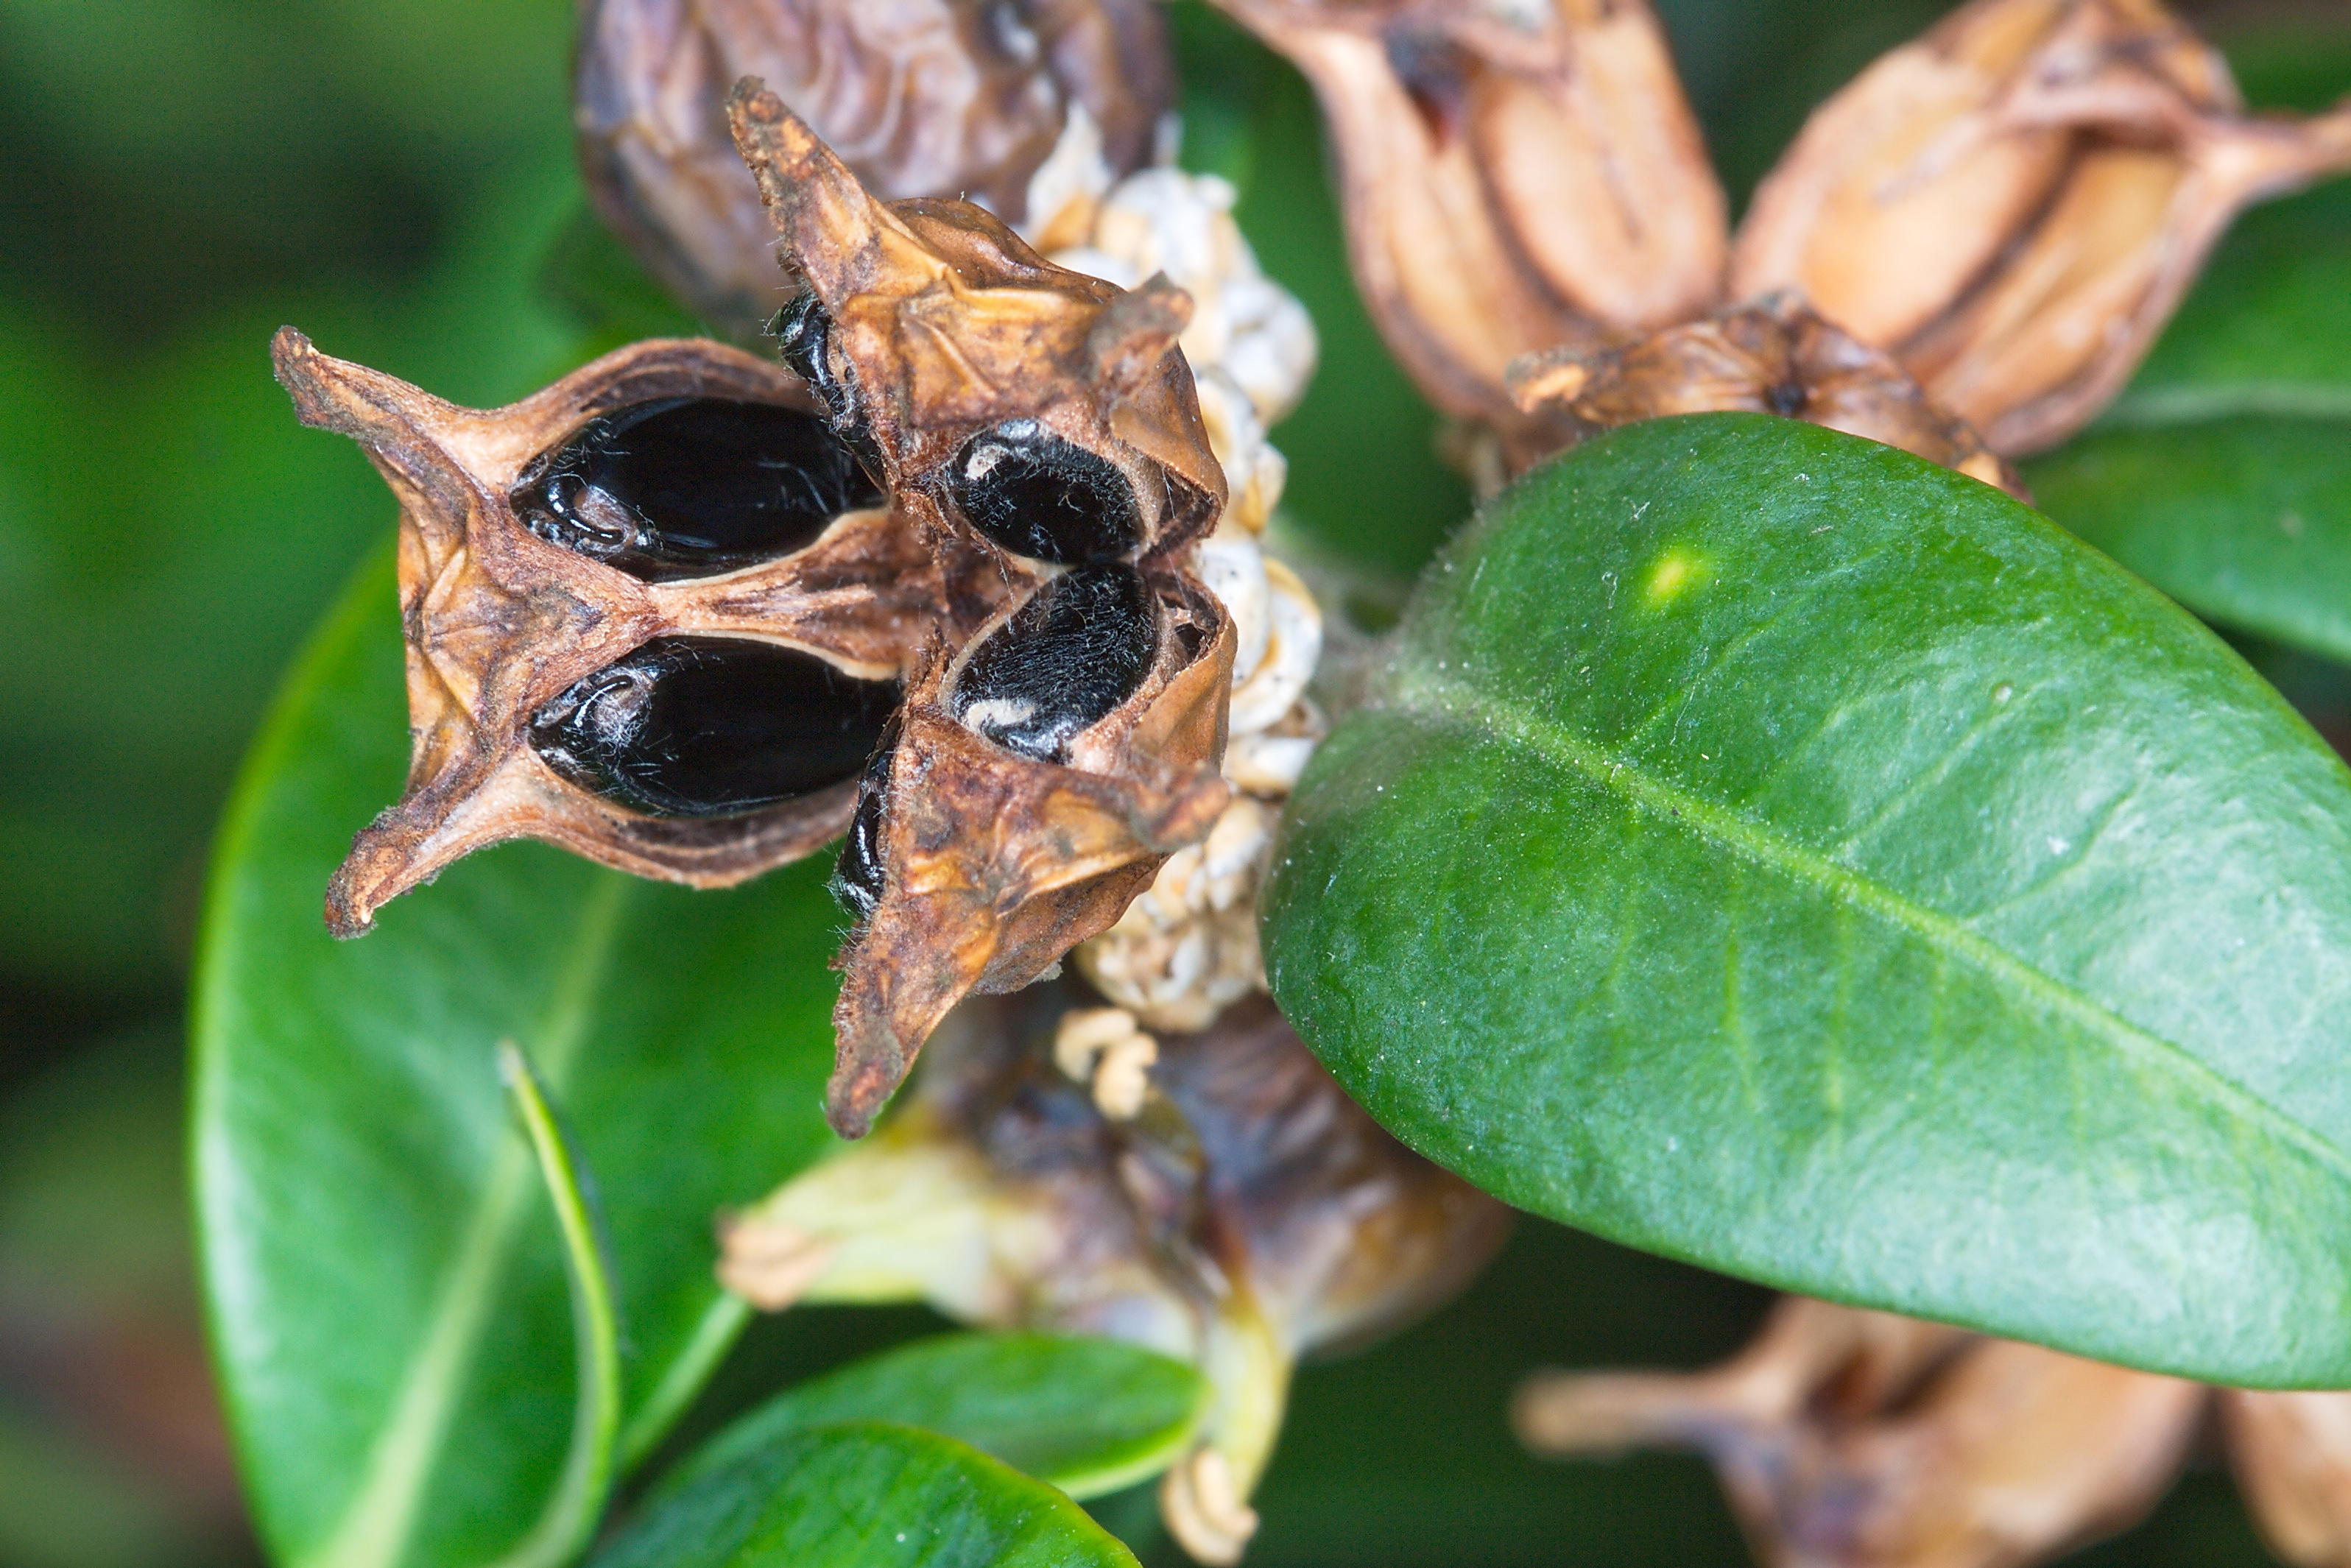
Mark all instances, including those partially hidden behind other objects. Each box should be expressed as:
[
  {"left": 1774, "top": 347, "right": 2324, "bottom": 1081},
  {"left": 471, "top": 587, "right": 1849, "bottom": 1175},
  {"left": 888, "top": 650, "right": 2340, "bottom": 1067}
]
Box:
[{"left": 1389, "top": 672, "right": 2351, "bottom": 1180}]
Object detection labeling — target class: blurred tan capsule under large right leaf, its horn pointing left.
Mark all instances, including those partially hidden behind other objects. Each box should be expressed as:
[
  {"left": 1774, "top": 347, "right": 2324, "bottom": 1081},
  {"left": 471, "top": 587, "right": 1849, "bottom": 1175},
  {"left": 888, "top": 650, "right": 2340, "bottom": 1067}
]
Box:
[{"left": 1514, "top": 1298, "right": 2205, "bottom": 1568}]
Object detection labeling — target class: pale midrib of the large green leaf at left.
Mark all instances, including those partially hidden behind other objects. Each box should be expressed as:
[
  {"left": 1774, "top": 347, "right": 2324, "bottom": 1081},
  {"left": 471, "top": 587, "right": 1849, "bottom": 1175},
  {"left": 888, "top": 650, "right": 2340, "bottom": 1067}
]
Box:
[{"left": 296, "top": 872, "right": 632, "bottom": 1568}]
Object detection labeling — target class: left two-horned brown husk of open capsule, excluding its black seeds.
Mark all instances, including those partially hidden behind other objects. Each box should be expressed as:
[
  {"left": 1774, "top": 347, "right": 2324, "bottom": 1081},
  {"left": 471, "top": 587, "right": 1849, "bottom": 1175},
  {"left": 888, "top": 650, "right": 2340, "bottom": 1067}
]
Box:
[{"left": 270, "top": 327, "right": 938, "bottom": 936}]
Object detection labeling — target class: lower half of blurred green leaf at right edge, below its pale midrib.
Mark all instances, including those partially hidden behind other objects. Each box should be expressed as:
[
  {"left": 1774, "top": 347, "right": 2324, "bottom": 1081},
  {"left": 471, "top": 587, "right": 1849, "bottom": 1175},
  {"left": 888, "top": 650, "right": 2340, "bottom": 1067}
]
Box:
[{"left": 2026, "top": 416, "right": 2351, "bottom": 660}]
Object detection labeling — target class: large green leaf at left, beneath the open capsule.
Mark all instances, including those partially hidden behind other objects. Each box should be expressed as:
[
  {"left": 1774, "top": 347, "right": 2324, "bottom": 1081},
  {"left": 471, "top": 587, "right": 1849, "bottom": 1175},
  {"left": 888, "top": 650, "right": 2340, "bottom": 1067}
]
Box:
[{"left": 193, "top": 559, "right": 842, "bottom": 1568}]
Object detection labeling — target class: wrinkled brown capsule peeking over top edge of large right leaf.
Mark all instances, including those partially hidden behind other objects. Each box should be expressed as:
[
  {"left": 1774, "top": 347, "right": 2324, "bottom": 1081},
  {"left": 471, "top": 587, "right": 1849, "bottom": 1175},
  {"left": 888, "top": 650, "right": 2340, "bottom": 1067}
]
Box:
[{"left": 1505, "top": 294, "right": 2029, "bottom": 498}]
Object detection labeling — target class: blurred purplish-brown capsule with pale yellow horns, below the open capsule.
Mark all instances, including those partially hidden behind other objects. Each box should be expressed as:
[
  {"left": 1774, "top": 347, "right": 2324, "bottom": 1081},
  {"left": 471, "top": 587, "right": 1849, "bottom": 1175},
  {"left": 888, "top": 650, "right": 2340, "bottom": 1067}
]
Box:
[{"left": 719, "top": 983, "right": 1509, "bottom": 1564}]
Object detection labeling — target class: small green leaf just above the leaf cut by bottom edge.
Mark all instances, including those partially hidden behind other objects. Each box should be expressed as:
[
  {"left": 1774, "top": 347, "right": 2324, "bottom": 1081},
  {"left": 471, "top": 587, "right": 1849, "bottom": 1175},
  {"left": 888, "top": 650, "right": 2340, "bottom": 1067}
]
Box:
[{"left": 663, "top": 1333, "right": 1208, "bottom": 1497}]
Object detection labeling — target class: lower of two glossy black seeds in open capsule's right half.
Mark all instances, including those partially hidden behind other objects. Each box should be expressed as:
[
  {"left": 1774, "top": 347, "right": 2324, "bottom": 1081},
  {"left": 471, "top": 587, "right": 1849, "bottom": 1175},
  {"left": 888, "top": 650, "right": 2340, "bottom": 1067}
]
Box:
[{"left": 952, "top": 567, "right": 1159, "bottom": 762}]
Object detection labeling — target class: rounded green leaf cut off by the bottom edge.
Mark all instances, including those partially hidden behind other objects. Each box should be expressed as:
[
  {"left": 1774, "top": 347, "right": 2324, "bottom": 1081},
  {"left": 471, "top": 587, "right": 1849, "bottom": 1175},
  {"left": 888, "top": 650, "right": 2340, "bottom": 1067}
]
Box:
[{"left": 595, "top": 1422, "right": 1135, "bottom": 1568}]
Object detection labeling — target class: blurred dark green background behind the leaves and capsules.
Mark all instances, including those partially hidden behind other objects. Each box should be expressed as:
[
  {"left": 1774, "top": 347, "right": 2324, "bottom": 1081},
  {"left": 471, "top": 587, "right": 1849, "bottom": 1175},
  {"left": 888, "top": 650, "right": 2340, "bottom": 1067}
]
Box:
[{"left": 0, "top": 0, "right": 2347, "bottom": 1568}]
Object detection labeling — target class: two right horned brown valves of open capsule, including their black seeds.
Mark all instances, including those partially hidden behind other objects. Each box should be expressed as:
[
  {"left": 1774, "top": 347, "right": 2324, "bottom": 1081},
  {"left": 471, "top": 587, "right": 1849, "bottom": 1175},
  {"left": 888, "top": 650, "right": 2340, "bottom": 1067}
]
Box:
[{"left": 729, "top": 82, "right": 1232, "bottom": 1135}]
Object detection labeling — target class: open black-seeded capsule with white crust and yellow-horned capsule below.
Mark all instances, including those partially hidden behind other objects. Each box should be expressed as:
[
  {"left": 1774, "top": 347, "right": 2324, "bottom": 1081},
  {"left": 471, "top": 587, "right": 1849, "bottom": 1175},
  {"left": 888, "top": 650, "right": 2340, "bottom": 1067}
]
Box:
[{"left": 275, "top": 36, "right": 1505, "bottom": 1561}]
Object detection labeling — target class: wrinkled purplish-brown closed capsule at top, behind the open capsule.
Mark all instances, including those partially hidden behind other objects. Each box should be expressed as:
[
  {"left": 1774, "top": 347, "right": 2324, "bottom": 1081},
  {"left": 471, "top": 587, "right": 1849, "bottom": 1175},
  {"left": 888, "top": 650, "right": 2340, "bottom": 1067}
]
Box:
[{"left": 576, "top": 0, "right": 1173, "bottom": 336}]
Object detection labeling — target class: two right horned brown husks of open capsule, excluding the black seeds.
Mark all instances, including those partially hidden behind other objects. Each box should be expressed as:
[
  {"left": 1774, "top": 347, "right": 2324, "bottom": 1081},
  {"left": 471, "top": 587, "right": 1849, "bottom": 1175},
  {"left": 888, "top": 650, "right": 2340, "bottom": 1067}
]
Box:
[{"left": 729, "top": 82, "right": 1232, "bottom": 1135}]
